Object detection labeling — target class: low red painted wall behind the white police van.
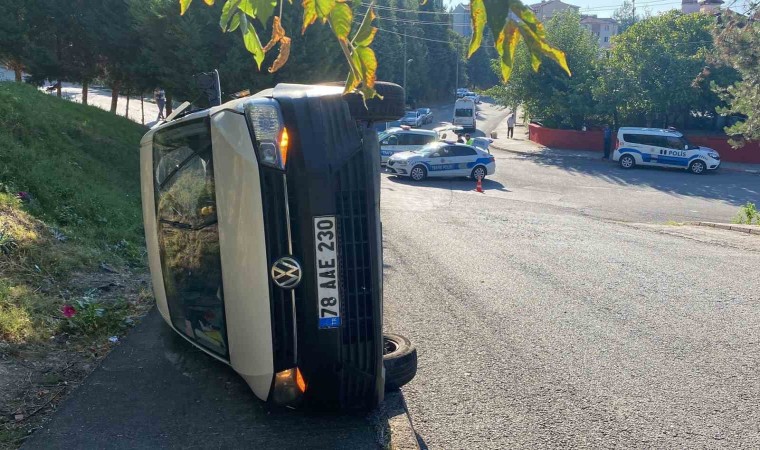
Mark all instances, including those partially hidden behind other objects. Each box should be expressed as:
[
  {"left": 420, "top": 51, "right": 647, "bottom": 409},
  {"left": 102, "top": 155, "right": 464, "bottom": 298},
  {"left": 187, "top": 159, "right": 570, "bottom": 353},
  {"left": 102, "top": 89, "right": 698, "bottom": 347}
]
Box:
[{"left": 529, "top": 123, "right": 760, "bottom": 164}]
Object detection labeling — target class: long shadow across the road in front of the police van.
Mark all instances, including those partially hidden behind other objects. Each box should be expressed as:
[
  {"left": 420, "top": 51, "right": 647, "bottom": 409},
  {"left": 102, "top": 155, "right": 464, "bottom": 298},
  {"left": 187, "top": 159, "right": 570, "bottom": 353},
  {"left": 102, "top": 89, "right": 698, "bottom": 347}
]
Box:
[{"left": 522, "top": 150, "right": 760, "bottom": 205}]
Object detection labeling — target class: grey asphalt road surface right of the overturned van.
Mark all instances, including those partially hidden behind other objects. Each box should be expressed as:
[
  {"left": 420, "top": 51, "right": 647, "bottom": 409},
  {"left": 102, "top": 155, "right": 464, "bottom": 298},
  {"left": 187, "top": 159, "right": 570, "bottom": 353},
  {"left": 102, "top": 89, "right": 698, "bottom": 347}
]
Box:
[{"left": 382, "top": 101, "right": 760, "bottom": 449}]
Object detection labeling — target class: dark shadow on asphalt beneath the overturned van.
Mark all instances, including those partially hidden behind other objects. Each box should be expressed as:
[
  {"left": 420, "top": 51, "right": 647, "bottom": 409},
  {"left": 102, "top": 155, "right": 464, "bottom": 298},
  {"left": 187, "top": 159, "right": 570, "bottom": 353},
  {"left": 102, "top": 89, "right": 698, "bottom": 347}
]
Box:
[{"left": 26, "top": 309, "right": 388, "bottom": 449}]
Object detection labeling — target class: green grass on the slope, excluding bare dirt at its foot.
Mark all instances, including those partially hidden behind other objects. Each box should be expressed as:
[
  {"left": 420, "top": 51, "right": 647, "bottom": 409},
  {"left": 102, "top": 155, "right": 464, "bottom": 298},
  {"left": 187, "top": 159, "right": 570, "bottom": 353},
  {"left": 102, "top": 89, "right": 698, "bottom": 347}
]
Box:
[{"left": 0, "top": 82, "right": 146, "bottom": 344}]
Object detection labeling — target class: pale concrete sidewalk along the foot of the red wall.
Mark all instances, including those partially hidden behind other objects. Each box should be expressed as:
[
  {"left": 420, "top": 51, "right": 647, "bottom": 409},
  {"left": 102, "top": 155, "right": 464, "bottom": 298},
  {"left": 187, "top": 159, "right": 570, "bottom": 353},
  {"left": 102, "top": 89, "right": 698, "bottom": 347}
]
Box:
[{"left": 491, "top": 120, "right": 760, "bottom": 174}]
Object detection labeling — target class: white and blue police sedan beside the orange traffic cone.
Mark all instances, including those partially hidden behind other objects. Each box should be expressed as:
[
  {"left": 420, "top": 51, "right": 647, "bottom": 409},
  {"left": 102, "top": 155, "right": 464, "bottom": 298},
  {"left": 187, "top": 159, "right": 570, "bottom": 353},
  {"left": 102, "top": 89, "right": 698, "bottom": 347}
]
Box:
[{"left": 386, "top": 142, "right": 496, "bottom": 181}]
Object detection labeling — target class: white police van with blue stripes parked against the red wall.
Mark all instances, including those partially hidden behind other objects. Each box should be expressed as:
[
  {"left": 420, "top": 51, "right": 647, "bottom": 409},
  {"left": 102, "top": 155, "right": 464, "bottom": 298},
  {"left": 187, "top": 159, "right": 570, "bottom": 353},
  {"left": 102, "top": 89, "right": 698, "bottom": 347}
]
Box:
[{"left": 612, "top": 127, "right": 720, "bottom": 174}]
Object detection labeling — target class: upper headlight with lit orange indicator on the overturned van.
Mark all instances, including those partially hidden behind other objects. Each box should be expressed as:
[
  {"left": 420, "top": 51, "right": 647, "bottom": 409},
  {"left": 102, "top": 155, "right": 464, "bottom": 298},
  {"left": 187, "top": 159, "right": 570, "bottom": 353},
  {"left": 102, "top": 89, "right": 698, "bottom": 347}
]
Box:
[{"left": 242, "top": 98, "right": 290, "bottom": 170}]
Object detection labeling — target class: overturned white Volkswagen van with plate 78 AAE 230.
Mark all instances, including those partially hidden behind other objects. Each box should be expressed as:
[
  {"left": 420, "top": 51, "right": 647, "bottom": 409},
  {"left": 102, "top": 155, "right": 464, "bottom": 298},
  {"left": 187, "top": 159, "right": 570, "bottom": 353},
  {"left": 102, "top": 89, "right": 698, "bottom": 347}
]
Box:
[{"left": 140, "top": 82, "right": 417, "bottom": 410}]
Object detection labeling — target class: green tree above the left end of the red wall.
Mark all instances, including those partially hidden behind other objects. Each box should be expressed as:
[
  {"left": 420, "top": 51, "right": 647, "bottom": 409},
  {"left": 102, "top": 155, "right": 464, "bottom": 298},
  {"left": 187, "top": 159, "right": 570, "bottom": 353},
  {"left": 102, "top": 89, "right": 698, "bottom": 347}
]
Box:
[{"left": 491, "top": 11, "right": 599, "bottom": 129}]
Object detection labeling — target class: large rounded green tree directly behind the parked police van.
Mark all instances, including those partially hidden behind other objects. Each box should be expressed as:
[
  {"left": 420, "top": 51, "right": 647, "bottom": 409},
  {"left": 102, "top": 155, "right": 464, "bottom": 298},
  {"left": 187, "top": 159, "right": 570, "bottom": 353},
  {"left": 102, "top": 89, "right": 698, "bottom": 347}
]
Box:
[{"left": 594, "top": 11, "right": 717, "bottom": 127}]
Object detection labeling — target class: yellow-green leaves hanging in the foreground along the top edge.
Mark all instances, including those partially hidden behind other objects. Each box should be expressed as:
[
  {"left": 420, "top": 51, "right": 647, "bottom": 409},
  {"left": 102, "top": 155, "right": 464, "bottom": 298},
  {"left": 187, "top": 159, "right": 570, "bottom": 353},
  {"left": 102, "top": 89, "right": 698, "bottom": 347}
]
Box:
[{"left": 179, "top": 0, "right": 570, "bottom": 98}]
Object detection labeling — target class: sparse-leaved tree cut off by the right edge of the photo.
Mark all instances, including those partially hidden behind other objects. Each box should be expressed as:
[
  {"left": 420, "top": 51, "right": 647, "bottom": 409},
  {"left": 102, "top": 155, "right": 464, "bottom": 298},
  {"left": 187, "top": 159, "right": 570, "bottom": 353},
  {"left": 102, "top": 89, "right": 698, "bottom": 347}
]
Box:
[{"left": 713, "top": 2, "right": 760, "bottom": 147}]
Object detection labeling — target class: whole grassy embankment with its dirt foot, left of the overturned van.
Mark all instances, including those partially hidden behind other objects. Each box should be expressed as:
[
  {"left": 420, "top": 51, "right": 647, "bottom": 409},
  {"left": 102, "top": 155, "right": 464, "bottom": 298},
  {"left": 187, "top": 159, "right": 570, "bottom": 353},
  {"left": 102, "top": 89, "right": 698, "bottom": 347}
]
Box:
[{"left": 0, "top": 83, "right": 150, "bottom": 447}]
